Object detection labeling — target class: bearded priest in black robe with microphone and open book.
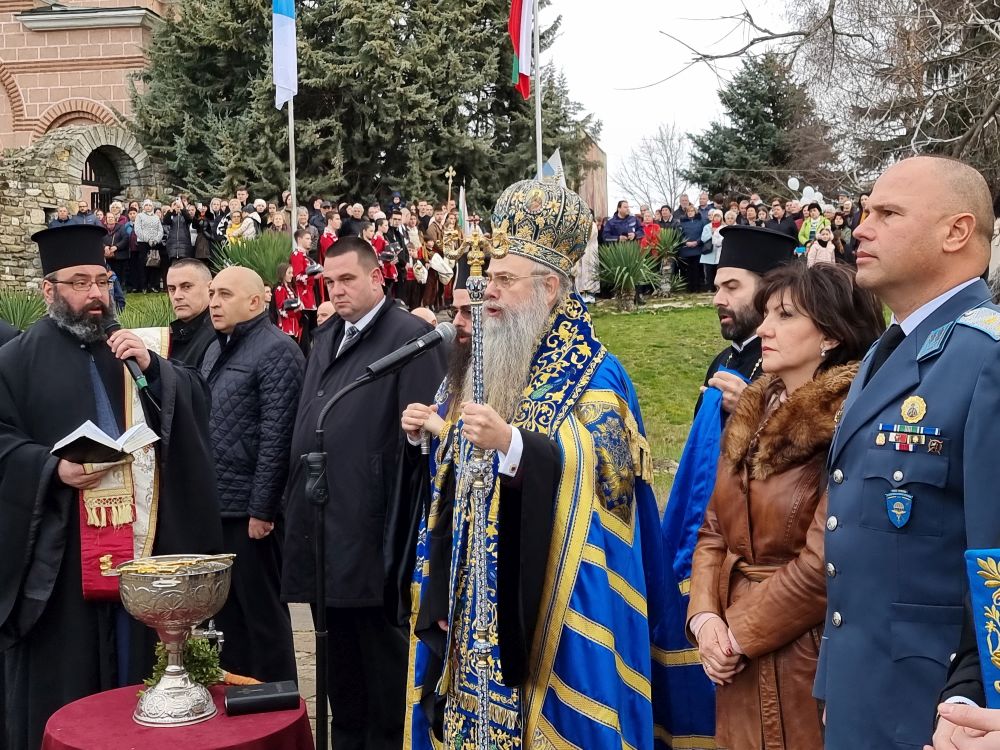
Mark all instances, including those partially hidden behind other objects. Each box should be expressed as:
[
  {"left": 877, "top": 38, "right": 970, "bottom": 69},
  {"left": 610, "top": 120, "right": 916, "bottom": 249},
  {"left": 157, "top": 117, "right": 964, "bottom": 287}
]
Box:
[{"left": 0, "top": 225, "right": 221, "bottom": 750}]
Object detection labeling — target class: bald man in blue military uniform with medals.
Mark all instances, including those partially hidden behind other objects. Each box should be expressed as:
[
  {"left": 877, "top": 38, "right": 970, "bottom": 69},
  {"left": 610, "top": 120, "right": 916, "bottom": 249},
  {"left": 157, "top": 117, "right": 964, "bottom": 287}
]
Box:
[{"left": 814, "top": 156, "right": 1000, "bottom": 750}]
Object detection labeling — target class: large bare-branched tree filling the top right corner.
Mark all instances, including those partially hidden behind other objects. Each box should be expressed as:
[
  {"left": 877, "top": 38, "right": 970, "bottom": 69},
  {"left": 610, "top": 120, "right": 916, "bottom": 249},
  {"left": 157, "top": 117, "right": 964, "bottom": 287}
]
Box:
[{"left": 664, "top": 0, "right": 1000, "bottom": 195}]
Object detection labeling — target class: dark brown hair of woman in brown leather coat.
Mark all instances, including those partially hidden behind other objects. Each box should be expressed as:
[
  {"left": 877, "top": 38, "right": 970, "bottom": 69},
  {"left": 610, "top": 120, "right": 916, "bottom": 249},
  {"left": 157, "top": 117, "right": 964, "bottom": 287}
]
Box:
[{"left": 753, "top": 263, "right": 885, "bottom": 372}]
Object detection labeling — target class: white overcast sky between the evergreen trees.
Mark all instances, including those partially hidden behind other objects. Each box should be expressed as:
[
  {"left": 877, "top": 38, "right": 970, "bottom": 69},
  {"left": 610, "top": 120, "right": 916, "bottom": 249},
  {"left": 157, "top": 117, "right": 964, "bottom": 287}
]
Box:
[{"left": 541, "top": 0, "right": 783, "bottom": 205}]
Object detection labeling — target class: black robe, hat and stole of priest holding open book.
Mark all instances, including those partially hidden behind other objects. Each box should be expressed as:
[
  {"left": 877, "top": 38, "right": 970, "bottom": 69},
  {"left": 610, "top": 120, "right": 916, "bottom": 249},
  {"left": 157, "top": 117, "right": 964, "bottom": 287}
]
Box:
[{"left": 0, "top": 226, "right": 221, "bottom": 750}]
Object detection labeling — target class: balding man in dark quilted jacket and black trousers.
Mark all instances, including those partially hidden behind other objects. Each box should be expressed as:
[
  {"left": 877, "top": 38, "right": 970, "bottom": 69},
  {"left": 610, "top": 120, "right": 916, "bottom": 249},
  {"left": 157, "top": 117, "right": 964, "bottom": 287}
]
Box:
[{"left": 201, "top": 266, "right": 305, "bottom": 682}]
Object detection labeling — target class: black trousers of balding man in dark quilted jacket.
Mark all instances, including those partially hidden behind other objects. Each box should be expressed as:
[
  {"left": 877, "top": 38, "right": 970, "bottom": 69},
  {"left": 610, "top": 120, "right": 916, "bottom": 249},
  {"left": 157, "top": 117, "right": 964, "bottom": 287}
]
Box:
[{"left": 215, "top": 518, "right": 296, "bottom": 682}]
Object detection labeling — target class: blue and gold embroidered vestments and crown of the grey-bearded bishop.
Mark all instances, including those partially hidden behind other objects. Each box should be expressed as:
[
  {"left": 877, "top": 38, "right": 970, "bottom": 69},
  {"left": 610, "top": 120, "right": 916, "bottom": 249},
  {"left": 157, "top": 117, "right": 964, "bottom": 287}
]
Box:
[{"left": 400, "top": 181, "right": 665, "bottom": 750}]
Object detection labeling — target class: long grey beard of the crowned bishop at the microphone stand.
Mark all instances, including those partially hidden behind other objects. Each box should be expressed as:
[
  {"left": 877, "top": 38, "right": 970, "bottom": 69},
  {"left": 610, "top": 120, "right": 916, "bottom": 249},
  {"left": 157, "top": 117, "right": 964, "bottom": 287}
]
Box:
[{"left": 464, "top": 282, "right": 552, "bottom": 421}]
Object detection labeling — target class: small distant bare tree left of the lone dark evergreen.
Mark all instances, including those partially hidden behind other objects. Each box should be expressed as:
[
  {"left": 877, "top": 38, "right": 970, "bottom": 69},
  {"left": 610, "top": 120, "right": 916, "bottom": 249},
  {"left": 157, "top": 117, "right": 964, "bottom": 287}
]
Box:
[{"left": 613, "top": 123, "right": 690, "bottom": 211}]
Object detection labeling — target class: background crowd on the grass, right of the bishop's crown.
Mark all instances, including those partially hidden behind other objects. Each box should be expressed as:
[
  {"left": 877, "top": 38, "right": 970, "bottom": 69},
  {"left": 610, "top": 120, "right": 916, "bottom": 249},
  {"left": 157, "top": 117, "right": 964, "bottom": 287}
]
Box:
[{"left": 599, "top": 191, "right": 869, "bottom": 292}]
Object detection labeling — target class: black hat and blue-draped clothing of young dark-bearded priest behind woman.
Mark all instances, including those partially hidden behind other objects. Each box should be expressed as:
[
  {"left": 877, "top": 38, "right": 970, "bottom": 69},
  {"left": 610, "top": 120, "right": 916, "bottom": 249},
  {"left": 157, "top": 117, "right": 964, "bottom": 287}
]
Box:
[{"left": 657, "top": 226, "right": 795, "bottom": 748}]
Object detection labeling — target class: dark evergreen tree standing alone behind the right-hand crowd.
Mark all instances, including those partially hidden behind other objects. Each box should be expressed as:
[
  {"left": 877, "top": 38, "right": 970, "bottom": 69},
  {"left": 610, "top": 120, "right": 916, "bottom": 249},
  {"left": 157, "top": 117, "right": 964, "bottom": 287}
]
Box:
[{"left": 684, "top": 53, "right": 832, "bottom": 194}]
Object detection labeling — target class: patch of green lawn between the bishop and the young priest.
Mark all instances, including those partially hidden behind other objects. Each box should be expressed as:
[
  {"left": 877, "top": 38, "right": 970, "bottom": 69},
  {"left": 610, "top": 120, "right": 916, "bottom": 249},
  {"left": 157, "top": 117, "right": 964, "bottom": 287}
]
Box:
[{"left": 593, "top": 295, "right": 725, "bottom": 506}]
